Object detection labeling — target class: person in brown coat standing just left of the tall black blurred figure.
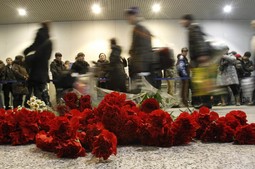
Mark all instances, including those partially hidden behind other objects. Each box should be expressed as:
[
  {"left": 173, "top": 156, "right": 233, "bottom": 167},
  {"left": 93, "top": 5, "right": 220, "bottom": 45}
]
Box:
[{"left": 12, "top": 55, "right": 28, "bottom": 108}]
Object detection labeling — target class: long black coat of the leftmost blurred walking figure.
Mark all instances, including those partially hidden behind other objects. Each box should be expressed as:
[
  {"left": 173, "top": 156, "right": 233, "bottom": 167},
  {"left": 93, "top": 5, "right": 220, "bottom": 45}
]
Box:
[{"left": 24, "top": 27, "right": 52, "bottom": 83}]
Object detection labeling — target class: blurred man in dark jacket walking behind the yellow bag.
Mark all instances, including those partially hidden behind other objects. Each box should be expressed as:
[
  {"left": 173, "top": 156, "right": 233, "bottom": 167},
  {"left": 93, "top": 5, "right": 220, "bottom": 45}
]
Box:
[{"left": 180, "top": 14, "right": 212, "bottom": 108}]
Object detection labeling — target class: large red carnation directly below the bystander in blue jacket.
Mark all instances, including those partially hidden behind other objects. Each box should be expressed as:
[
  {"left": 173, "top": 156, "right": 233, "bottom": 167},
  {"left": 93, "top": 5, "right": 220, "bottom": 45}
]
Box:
[{"left": 171, "top": 112, "right": 198, "bottom": 145}]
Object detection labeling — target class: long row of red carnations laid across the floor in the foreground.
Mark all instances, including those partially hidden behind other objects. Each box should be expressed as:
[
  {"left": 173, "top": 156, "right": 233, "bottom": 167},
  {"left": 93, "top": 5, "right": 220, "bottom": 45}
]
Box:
[{"left": 0, "top": 92, "right": 255, "bottom": 160}]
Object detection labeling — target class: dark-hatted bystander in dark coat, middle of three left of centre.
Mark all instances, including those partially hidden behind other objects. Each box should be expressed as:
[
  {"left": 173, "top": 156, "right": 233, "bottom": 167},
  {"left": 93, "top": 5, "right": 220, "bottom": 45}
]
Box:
[{"left": 71, "top": 52, "right": 89, "bottom": 74}]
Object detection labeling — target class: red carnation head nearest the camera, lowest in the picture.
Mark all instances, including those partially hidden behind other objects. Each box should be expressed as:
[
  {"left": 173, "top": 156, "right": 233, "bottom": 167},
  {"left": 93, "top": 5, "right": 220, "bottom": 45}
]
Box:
[{"left": 92, "top": 130, "right": 117, "bottom": 160}]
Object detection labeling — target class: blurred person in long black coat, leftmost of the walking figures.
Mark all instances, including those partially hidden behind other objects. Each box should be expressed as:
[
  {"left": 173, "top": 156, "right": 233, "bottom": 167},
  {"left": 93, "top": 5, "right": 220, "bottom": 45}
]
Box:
[{"left": 24, "top": 21, "right": 52, "bottom": 106}]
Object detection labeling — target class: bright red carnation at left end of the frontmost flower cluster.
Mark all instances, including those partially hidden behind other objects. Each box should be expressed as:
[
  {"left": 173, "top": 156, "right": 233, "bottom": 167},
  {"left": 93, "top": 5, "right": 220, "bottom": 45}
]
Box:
[{"left": 35, "top": 131, "right": 57, "bottom": 152}]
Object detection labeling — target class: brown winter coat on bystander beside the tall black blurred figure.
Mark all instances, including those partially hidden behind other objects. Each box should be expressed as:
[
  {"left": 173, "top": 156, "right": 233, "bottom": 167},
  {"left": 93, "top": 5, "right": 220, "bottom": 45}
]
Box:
[{"left": 12, "top": 61, "right": 28, "bottom": 95}]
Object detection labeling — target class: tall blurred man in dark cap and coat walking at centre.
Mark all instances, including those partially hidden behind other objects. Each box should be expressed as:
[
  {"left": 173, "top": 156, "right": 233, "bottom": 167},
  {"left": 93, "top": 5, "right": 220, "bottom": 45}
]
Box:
[{"left": 126, "top": 7, "right": 156, "bottom": 93}]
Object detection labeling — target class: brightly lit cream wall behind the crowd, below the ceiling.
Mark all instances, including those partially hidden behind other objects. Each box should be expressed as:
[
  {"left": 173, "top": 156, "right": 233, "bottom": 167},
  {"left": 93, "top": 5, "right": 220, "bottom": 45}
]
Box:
[{"left": 0, "top": 20, "right": 252, "bottom": 62}]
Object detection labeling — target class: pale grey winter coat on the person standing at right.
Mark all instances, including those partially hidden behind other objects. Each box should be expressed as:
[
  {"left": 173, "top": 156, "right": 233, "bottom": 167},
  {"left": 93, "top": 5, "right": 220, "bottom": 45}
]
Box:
[{"left": 218, "top": 54, "right": 239, "bottom": 86}]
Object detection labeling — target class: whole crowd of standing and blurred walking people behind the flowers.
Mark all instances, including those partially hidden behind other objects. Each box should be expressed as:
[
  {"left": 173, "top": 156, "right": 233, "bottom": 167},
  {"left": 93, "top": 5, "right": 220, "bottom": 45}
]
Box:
[{"left": 0, "top": 7, "right": 254, "bottom": 109}]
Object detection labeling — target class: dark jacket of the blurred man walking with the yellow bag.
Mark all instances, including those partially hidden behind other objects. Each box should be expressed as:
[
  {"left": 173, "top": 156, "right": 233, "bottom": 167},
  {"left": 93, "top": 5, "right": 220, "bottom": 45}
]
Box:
[{"left": 188, "top": 23, "right": 209, "bottom": 67}]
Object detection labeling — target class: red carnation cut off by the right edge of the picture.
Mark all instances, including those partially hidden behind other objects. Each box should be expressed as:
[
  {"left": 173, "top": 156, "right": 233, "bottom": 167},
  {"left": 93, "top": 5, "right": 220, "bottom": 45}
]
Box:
[{"left": 235, "top": 123, "right": 255, "bottom": 144}]
